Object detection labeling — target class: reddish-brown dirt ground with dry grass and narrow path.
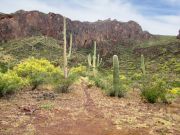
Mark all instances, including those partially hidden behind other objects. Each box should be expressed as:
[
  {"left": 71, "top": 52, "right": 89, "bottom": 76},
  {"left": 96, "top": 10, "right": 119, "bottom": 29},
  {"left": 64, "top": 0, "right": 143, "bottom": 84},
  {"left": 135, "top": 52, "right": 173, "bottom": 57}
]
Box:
[{"left": 0, "top": 79, "right": 180, "bottom": 135}]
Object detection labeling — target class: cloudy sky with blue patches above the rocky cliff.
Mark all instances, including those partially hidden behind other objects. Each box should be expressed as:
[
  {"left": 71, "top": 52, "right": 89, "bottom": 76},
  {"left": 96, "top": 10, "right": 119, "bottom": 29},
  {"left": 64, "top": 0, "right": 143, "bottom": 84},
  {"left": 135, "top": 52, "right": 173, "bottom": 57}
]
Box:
[{"left": 0, "top": 0, "right": 180, "bottom": 35}]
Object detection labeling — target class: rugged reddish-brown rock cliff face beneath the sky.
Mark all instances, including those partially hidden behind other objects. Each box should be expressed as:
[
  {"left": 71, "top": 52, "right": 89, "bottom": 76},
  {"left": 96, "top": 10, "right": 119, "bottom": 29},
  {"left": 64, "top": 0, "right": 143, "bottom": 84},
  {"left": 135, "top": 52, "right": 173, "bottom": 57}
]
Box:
[{"left": 0, "top": 10, "right": 152, "bottom": 47}]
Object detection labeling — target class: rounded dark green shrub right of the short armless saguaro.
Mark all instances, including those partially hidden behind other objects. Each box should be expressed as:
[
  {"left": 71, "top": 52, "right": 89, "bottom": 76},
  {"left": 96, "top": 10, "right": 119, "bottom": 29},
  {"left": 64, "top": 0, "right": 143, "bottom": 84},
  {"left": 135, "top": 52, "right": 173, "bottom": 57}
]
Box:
[{"left": 141, "top": 77, "right": 168, "bottom": 103}]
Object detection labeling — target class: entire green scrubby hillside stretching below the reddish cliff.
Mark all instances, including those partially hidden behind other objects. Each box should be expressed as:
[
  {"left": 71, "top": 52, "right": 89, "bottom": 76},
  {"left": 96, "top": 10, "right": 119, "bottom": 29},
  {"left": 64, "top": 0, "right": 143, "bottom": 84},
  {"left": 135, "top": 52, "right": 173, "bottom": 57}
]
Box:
[{"left": 0, "top": 36, "right": 180, "bottom": 76}]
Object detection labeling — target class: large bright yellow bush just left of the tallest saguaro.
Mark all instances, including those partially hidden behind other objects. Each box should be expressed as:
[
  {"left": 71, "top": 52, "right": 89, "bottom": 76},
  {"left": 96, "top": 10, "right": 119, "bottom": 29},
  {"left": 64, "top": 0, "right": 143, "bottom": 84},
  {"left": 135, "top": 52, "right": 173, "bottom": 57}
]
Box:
[{"left": 13, "top": 58, "right": 62, "bottom": 89}]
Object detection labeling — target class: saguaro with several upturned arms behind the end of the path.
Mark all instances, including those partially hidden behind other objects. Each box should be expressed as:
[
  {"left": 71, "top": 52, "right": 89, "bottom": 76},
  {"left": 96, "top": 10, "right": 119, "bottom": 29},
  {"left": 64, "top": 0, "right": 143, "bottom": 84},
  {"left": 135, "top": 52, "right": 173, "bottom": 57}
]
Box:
[{"left": 88, "top": 41, "right": 102, "bottom": 76}]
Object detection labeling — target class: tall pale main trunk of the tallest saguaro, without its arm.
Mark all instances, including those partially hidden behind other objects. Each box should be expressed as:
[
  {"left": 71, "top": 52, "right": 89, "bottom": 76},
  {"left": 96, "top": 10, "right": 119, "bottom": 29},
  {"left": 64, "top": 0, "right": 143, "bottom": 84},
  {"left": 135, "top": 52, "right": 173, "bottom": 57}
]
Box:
[{"left": 63, "top": 17, "right": 68, "bottom": 78}]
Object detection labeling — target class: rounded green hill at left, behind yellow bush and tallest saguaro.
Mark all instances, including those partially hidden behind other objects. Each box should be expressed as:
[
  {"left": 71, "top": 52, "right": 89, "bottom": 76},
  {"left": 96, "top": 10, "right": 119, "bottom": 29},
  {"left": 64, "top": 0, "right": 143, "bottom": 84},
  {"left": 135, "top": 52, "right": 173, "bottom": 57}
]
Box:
[{"left": 0, "top": 36, "right": 86, "bottom": 71}]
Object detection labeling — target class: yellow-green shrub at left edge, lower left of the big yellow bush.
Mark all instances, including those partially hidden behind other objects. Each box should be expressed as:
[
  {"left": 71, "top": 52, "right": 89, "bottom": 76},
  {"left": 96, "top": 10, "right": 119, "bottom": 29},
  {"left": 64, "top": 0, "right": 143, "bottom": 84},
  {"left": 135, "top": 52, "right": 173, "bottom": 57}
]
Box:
[{"left": 0, "top": 71, "right": 28, "bottom": 96}]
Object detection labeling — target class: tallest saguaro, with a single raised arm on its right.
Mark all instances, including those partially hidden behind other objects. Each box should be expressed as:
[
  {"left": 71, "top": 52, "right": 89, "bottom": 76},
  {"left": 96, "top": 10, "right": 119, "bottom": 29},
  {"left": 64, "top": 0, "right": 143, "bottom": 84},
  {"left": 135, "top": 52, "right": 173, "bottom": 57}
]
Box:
[{"left": 63, "top": 17, "right": 72, "bottom": 78}]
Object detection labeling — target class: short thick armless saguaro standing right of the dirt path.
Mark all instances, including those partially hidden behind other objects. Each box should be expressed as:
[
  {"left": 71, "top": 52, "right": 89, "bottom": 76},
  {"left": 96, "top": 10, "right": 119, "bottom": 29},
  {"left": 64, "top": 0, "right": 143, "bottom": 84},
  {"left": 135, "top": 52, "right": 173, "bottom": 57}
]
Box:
[{"left": 113, "top": 55, "right": 120, "bottom": 97}]
